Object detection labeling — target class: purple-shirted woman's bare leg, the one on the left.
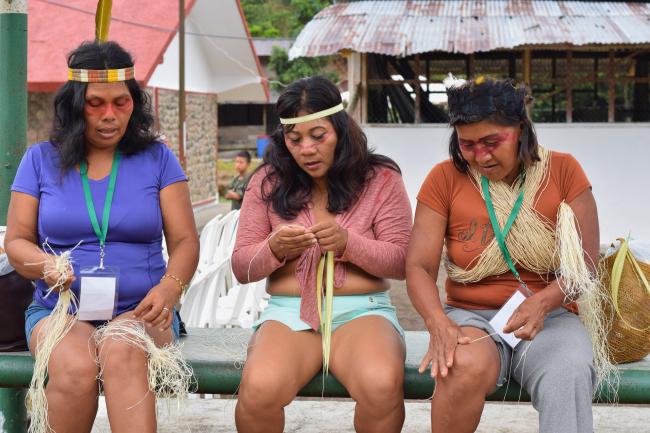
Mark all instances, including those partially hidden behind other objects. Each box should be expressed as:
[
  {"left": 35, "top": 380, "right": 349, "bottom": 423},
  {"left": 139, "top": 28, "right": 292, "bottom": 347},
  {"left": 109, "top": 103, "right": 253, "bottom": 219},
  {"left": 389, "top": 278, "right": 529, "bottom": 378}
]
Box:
[{"left": 30, "top": 318, "right": 99, "bottom": 433}]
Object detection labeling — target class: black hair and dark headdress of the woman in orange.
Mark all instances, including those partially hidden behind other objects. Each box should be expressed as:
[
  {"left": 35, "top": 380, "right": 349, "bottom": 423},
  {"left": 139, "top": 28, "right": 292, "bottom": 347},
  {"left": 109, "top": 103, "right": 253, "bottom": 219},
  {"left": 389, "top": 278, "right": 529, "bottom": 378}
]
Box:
[{"left": 447, "top": 76, "right": 540, "bottom": 173}]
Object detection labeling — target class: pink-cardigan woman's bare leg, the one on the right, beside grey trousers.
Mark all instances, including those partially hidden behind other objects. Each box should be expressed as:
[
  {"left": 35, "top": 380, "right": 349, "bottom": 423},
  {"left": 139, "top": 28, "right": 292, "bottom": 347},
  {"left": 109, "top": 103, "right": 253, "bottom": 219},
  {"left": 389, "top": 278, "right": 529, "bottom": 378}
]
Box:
[{"left": 330, "top": 316, "right": 405, "bottom": 433}]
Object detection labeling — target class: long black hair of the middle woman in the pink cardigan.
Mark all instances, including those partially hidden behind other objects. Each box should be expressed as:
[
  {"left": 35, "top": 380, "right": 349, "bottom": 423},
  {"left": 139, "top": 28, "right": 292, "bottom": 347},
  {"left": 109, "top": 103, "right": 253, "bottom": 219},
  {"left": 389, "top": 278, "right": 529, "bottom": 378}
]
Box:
[{"left": 258, "top": 77, "right": 400, "bottom": 219}]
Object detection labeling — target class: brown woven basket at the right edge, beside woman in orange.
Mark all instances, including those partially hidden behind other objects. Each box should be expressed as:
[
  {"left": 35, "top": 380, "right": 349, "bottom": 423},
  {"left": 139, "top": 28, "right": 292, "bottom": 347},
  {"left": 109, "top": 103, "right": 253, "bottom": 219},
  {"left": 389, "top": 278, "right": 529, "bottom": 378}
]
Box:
[{"left": 602, "top": 240, "right": 650, "bottom": 363}]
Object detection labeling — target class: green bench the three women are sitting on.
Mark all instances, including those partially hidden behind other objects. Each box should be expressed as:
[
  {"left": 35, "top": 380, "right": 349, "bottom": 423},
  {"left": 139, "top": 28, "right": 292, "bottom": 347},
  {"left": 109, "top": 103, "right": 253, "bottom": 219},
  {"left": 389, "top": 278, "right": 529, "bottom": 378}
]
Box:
[{"left": 0, "top": 328, "right": 650, "bottom": 433}]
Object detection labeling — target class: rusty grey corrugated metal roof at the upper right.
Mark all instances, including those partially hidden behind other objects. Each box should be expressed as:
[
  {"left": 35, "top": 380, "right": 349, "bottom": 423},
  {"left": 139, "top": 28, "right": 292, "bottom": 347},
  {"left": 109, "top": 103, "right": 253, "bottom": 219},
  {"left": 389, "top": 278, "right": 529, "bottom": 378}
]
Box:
[{"left": 289, "top": 0, "right": 650, "bottom": 58}]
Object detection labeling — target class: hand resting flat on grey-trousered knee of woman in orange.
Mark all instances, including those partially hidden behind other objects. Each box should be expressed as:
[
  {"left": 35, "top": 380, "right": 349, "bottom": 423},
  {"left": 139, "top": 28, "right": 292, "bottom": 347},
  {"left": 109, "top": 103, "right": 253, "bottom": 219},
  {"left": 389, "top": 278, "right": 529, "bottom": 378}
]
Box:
[{"left": 418, "top": 312, "right": 470, "bottom": 378}]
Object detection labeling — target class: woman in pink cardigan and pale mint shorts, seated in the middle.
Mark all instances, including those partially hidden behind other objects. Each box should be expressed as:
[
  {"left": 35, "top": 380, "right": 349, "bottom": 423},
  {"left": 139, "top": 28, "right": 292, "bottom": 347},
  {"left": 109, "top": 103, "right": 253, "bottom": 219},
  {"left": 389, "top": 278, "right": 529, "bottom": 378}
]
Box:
[{"left": 232, "top": 77, "right": 412, "bottom": 433}]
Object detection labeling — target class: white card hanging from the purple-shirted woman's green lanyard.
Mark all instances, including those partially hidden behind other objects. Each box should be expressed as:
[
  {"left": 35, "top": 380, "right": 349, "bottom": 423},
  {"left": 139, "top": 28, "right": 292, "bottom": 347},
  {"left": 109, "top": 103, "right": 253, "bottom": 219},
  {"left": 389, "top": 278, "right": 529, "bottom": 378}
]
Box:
[{"left": 79, "top": 277, "right": 117, "bottom": 320}]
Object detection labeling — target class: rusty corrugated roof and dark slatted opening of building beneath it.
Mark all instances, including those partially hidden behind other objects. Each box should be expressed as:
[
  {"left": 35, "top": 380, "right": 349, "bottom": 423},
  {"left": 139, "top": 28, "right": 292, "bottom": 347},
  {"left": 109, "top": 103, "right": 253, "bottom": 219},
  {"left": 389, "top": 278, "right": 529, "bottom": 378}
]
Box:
[{"left": 289, "top": 0, "right": 650, "bottom": 123}]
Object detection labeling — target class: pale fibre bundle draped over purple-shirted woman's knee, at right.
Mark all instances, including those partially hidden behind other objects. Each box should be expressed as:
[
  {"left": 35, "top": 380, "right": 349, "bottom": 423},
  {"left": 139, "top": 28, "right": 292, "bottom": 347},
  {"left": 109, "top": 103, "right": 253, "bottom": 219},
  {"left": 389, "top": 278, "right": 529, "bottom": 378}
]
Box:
[{"left": 94, "top": 319, "right": 193, "bottom": 409}]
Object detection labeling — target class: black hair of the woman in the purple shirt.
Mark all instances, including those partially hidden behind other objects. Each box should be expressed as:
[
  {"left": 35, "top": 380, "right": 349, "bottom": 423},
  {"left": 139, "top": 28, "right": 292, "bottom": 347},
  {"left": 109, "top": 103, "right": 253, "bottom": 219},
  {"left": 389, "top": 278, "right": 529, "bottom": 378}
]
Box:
[{"left": 50, "top": 41, "right": 159, "bottom": 171}]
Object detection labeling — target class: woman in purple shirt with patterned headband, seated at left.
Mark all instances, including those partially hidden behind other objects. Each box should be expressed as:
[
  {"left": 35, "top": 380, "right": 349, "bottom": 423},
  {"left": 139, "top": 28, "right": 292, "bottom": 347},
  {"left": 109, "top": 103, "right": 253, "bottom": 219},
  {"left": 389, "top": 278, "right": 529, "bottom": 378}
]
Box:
[{"left": 5, "top": 42, "right": 199, "bottom": 433}]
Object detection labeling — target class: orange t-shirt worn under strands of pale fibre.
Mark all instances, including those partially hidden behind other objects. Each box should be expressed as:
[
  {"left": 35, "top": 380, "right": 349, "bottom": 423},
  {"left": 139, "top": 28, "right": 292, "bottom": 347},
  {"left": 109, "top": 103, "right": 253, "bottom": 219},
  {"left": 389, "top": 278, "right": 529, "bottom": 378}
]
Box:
[{"left": 417, "top": 152, "right": 591, "bottom": 309}]
